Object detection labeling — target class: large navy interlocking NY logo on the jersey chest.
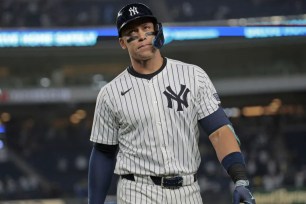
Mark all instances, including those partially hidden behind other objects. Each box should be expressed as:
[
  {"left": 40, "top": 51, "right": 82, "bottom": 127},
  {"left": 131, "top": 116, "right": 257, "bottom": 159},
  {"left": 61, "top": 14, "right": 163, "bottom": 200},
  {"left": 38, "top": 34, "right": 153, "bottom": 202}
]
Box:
[{"left": 163, "top": 84, "right": 190, "bottom": 111}]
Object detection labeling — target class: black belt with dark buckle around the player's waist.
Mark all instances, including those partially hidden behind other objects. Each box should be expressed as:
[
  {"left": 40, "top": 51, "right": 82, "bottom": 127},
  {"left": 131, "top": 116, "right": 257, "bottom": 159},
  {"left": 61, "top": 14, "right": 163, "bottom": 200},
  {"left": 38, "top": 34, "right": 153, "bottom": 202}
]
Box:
[{"left": 121, "top": 174, "right": 197, "bottom": 189}]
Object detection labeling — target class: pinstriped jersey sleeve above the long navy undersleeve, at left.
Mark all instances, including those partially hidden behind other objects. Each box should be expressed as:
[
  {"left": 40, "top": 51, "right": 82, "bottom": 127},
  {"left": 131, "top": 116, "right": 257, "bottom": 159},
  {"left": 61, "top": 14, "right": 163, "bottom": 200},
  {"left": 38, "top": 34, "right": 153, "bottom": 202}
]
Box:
[{"left": 90, "top": 88, "right": 119, "bottom": 145}]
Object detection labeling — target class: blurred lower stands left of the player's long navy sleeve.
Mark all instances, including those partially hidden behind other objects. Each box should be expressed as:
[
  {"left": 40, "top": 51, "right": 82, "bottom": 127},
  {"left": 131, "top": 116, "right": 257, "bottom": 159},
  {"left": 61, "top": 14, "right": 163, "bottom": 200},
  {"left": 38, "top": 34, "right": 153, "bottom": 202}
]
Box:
[{"left": 0, "top": 106, "right": 94, "bottom": 200}]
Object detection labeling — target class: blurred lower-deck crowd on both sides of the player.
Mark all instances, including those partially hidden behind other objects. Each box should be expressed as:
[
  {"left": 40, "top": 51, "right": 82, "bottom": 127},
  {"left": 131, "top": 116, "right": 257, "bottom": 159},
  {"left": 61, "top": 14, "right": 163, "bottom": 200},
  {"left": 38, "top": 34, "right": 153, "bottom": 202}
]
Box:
[{"left": 0, "top": 105, "right": 306, "bottom": 199}]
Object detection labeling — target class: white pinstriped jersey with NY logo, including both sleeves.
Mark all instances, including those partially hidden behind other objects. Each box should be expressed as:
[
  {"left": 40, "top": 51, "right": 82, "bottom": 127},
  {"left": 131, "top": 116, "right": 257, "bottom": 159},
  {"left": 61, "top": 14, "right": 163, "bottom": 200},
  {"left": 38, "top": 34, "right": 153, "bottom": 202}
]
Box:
[{"left": 90, "top": 58, "right": 220, "bottom": 175}]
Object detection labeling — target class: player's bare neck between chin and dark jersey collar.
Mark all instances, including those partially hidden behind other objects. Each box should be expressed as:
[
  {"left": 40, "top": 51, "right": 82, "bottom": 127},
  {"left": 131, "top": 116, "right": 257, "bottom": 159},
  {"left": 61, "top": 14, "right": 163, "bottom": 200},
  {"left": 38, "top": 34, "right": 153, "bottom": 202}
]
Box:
[{"left": 131, "top": 53, "right": 163, "bottom": 74}]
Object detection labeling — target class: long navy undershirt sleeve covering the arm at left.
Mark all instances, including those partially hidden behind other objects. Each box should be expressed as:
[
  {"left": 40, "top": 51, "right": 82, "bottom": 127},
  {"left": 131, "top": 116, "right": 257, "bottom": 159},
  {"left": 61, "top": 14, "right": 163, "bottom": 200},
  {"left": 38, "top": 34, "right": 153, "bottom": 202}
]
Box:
[{"left": 88, "top": 145, "right": 118, "bottom": 204}]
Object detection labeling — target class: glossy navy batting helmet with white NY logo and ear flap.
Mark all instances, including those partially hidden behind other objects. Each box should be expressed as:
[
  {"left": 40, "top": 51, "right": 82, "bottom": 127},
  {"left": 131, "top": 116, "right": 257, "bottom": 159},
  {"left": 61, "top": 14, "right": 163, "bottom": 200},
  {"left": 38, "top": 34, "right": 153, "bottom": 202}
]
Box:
[{"left": 116, "top": 3, "right": 164, "bottom": 48}]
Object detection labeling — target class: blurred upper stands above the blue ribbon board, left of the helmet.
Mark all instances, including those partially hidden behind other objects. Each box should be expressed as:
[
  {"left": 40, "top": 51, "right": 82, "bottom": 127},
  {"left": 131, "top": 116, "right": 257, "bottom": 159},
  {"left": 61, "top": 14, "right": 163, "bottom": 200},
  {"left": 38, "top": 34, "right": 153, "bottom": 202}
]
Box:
[{"left": 0, "top": 0, "right": 118, "bottom": 28}]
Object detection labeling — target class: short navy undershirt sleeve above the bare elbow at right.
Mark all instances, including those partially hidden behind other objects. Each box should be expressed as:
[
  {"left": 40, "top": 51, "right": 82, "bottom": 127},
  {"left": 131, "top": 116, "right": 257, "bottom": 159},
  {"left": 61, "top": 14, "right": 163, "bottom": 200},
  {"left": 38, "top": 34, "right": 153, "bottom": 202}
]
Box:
[{"left": 199, "top": 107, "right": 231, "bottom": 135}]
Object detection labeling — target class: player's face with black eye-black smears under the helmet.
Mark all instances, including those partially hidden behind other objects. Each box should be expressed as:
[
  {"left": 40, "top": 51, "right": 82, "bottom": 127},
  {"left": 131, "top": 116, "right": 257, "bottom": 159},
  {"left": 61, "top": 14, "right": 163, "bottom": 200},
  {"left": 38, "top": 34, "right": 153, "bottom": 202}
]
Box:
[{"left": 119, "top": 21, "right": 156, "bottom": 60}]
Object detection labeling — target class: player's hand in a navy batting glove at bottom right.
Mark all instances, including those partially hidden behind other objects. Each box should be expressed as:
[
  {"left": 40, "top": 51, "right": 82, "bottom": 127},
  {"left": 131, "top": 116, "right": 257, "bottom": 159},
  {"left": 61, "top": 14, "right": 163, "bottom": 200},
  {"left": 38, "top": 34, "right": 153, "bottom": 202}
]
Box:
[{"left": 233, "top": 180, "right": 256, "bottom": 204}]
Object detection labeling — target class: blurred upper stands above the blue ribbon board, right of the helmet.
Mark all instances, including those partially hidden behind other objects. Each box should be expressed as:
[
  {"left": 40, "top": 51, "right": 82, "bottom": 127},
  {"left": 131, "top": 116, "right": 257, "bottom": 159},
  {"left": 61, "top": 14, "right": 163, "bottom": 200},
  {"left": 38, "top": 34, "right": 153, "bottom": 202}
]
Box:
[{"left": 167, "top": 0, "right": 306, "bottom": 22}]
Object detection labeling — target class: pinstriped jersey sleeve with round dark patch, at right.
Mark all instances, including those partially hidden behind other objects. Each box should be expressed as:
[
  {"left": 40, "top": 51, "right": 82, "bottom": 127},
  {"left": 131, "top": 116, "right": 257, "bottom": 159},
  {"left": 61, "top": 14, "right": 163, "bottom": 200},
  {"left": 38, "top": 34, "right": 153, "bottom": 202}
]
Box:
[{"left": 195, "top": 68, "right": 221, "bottom": 120}]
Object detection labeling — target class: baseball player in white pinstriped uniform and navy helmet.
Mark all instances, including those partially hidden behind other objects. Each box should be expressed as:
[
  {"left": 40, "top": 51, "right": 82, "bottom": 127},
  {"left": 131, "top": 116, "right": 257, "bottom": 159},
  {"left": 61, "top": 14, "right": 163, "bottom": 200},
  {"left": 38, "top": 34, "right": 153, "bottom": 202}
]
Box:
[{"left": 88, "top": 3, "right": 255, "bottom": 204}]
